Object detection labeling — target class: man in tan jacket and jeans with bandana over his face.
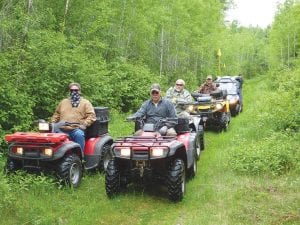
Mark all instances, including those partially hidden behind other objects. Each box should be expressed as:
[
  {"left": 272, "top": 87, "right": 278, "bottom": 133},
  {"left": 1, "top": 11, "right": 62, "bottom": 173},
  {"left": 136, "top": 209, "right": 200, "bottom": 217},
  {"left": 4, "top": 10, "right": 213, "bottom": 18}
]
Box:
[{"left": 51, "top": 83, "right": 96, "bottom": 152}]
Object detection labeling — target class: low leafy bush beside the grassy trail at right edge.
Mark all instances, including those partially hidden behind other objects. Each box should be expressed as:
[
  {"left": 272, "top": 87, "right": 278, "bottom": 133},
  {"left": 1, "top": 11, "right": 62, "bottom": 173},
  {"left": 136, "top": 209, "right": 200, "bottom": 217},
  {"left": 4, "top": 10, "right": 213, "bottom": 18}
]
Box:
[{"left": 230, "top": 133, "right": 300, "bottom": 175}]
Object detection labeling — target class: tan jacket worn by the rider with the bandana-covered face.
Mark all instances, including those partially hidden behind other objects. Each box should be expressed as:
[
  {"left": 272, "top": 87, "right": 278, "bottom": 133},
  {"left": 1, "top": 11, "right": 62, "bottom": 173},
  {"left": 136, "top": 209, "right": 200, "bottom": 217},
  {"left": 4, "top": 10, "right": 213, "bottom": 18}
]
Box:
[{"left": 51, "top": 97, "right": 96, "bottom": 130}]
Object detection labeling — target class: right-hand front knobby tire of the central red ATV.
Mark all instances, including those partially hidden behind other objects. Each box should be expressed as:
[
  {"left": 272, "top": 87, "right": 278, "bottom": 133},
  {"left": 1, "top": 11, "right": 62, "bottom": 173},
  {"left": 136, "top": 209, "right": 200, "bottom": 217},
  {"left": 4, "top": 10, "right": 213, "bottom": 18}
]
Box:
[{"left": 167, "top": 159, "right": 186, "bottom": 202}]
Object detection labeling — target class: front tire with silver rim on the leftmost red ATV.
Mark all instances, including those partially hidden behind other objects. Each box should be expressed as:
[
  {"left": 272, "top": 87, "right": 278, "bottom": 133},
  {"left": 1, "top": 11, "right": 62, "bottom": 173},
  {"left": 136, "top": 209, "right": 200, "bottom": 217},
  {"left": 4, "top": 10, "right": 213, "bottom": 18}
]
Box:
[{"left": 57, "top": 154, "right": 82, "bottom": 188}]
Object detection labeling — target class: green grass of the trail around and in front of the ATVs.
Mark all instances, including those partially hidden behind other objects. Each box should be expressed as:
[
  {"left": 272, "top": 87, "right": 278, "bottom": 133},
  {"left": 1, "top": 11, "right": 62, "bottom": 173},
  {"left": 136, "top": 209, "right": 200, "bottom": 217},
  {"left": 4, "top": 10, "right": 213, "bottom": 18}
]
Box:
[{"left": 0, "top": 78, "right": 300, "bottom": 225}]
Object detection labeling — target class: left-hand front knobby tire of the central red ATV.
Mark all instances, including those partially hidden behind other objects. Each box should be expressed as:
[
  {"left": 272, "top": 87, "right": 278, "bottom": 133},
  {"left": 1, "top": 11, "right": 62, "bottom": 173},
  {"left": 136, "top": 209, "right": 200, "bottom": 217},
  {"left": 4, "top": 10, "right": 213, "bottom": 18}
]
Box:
[{"left": 105, "top": 160, "right": 121, "bottom": 198}]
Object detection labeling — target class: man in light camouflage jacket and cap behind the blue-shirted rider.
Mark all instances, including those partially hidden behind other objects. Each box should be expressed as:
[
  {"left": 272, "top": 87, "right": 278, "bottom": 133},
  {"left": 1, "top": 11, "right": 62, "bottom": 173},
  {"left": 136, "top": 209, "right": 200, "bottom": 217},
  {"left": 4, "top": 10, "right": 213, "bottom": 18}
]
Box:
[{"left": 165, "top": 79, "right": 193, "bottom": 118}]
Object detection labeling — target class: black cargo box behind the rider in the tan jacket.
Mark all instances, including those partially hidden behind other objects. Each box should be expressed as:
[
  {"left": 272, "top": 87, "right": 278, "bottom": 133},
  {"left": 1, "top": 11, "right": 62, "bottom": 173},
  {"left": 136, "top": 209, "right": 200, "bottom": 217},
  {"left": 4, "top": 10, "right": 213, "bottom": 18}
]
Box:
[{"left": 86, "top": 107, "right": 109, "bottom": 138}]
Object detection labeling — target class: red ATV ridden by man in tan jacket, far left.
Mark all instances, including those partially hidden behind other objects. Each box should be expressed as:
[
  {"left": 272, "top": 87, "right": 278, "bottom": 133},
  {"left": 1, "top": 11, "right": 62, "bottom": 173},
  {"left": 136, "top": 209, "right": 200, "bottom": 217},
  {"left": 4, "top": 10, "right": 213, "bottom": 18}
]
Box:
[{"left": 5, "top": 107, "right": 113, "bottom": 187}]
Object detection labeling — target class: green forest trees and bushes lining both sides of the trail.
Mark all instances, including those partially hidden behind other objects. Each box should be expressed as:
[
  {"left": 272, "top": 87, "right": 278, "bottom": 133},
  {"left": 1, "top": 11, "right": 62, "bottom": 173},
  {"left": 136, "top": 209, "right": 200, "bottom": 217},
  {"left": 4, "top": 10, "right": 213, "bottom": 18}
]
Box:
[{"left": 0, "top": 0, "right": 300, "bottom": 223}]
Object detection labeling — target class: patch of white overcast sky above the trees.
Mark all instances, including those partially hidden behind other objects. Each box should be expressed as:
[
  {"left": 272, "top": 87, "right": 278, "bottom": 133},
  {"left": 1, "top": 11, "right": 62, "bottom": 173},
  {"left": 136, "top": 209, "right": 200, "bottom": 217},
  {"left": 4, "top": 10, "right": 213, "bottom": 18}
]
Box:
[{"left": 226, "top": 0, "right": 284, "bottom": 28}]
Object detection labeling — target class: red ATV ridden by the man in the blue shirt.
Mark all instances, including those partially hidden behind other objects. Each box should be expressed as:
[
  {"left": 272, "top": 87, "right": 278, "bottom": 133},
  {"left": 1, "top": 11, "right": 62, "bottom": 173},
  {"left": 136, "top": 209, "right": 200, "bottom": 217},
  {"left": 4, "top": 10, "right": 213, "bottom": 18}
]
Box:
[{"left": 105, "top": 119, "right": 200, "bottom": 201}]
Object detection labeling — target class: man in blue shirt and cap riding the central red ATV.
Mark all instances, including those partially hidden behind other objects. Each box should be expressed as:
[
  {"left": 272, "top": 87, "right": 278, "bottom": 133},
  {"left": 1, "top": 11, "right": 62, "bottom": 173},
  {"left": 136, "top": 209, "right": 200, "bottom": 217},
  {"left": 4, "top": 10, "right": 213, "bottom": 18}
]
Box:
[{"left": 133, "top": 84, "right": 177, "bottom": 136}]
